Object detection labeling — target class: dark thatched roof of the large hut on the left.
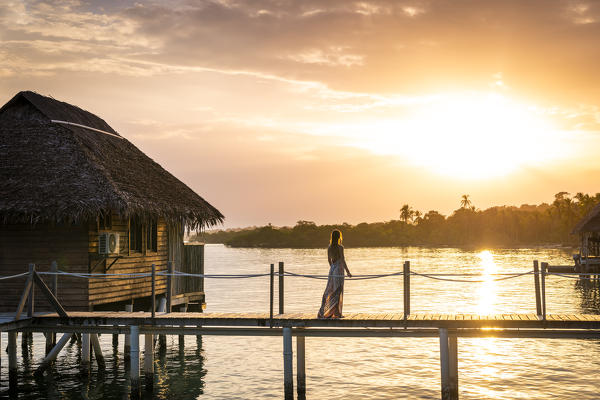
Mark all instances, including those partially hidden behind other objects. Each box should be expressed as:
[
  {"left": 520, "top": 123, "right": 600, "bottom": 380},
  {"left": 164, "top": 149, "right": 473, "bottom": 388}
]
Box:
[{"left": 0, "top": 92, "right": 224, "bottom": 229}]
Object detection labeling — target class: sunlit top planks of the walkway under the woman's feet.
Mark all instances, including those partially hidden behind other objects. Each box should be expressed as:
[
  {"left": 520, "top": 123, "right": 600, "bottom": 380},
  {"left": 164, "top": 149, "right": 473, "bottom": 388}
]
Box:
[{"left": 21, "top": 311, "right": 600, "bottom": 329}]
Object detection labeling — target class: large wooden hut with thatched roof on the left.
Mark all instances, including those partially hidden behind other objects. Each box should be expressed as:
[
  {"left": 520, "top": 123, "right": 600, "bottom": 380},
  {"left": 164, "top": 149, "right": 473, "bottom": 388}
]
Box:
[{"left": 0, "top": 92, "right": 223, "bottom": 312}]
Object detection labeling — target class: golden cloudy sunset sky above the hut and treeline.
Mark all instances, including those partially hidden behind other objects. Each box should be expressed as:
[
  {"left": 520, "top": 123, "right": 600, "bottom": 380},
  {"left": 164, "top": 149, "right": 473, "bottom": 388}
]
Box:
[{"left": 0, "top": 0, "right": 600, "bottom": 227}]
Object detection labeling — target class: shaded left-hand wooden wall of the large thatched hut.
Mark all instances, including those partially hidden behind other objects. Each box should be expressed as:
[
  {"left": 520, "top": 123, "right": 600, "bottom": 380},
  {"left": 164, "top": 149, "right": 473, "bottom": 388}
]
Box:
[{"left": 0, "top": 224, "right": 89, "bottom": 312}]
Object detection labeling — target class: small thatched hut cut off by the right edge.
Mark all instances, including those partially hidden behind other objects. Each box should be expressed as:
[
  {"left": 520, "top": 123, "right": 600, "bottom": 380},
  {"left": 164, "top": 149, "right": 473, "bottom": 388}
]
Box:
[{"left": 573, "top": 204, "right": 600, "bottom": 271}]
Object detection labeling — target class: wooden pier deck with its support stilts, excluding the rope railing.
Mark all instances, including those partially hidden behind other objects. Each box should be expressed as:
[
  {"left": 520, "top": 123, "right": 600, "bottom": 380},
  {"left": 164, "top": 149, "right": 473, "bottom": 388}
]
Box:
[{"left": 0, "top": 311, "right": 600, "bottom": 399}]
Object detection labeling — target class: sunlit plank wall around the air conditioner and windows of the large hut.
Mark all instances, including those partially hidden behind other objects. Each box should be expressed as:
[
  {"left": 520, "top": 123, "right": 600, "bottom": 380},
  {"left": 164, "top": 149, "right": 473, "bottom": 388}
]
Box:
[{"left": 88, "top": 214, "right": 168, "bottom": 306}]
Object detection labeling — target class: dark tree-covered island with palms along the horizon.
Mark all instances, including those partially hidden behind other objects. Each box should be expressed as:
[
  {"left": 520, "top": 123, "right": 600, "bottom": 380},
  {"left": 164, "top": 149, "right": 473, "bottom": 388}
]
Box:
[{"left": 191, "top": 192, "right": 600, "bottom": 248}]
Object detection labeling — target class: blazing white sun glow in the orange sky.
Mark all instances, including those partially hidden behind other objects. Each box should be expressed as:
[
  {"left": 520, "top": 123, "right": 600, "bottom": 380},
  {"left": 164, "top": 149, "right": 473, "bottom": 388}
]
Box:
[{"left": 360, "top": 92, "right": 568, "bottom": 179}]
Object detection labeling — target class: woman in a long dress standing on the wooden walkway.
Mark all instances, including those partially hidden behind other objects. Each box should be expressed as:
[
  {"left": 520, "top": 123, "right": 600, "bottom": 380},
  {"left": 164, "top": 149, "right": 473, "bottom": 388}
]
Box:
[{"left": 317, "top": 229, "right": 352, "bottom": 318}]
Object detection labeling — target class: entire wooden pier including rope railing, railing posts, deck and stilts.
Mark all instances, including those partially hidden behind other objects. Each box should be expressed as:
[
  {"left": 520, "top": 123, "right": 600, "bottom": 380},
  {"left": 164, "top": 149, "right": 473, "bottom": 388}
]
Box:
[{"left": 0, "top": 261, "right": 600, "bottom": 400}]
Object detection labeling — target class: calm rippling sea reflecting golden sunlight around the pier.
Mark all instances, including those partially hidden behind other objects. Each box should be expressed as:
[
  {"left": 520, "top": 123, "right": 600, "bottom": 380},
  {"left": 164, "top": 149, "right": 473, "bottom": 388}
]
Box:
[{"left": 1, "top": 245, "right": 600, "bottom": 400}]
